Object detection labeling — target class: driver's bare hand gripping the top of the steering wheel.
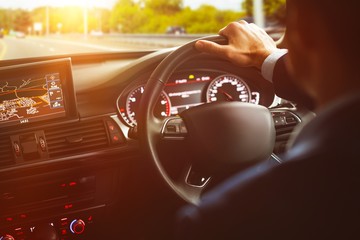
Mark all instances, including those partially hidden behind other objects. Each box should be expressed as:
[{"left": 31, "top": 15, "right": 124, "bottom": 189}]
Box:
[{"left": 195, "top": 20, "right": 277, "bottom": 69}]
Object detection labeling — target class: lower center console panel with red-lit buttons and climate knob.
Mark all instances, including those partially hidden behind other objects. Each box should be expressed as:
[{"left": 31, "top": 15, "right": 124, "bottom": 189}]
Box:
[{"left": 0, "top": 169, "right": 116, "bottom": 240}]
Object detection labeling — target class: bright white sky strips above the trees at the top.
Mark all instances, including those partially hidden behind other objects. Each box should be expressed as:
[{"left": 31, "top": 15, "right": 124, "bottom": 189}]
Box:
[{"left": 0, "top": 0, "right": 243, "bottom": 11}]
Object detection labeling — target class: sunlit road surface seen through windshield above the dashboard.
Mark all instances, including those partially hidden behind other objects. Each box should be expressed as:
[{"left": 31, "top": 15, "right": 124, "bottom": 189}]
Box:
[{"left": 0, "top": 32, "right": 282, "bottom": 60}]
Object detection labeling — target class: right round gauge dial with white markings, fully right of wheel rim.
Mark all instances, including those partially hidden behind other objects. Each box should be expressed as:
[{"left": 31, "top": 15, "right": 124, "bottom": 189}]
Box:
[{"left": 206, "top": 75, "right": 251, "bottom": 102}]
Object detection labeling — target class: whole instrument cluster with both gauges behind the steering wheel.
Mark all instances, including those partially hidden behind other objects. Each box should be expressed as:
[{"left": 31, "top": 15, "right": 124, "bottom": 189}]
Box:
[{"left": 117, "top": 70, "right": 270, "bottom": 127}]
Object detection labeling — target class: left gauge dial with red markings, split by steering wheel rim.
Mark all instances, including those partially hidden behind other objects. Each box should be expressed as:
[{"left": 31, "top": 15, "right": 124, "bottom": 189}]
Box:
[{"left": 120, "top": 85, "right": 171, "bottom": 127}]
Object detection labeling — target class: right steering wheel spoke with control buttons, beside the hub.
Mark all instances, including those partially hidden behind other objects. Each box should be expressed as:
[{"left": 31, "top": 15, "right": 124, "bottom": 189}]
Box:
[{"left": 272, "top": 111, "right": 300, "bottom": 154}]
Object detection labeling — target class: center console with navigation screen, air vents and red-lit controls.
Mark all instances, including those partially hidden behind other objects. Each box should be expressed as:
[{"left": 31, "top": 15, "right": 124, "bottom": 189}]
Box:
[{"left": 0, "top": 58, "right": 124, "bottom": 240}]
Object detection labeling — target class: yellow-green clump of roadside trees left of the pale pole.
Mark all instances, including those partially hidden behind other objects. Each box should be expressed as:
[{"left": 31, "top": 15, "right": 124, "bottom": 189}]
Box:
[{"left": 111, "top": 0, "right": 244, "bottom": 33}]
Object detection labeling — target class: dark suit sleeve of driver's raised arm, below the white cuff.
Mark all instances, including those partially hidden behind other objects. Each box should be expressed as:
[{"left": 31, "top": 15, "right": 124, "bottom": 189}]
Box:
[{"left": 273, "top": 54, "right": 314, "bottom": 109}]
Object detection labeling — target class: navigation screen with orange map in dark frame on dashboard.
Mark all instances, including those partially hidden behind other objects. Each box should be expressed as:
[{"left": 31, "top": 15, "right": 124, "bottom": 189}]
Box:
[{"left": 0, "top": 59, "right": 76, "bottom": 127}]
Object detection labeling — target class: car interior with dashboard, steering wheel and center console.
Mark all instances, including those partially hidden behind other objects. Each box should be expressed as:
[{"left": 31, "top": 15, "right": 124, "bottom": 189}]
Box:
[{"left": 0, "top": 2, "right": 309, "bottom": 240}]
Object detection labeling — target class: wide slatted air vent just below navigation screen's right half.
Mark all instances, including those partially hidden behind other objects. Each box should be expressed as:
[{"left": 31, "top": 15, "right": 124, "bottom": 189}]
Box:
[{"left": 45, "top": 120, "right": 109, "bottom": 158}]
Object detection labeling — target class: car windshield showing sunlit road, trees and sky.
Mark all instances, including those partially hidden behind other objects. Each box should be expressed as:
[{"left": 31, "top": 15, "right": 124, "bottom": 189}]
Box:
[{"left": 0, "top": 0, "right": 285, "bottom": 59}]
